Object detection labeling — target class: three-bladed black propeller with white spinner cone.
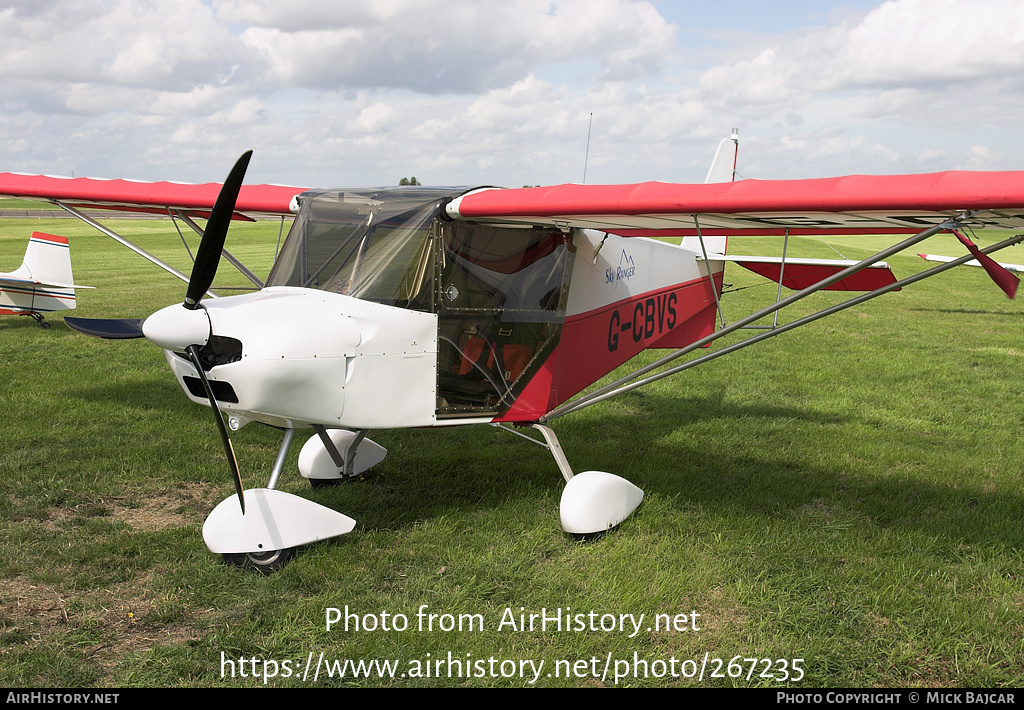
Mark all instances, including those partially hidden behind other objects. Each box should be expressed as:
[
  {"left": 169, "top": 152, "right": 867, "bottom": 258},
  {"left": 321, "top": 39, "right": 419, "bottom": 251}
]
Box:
[{"left": 65, "top": 151, "right": 252, "bottom": 514}]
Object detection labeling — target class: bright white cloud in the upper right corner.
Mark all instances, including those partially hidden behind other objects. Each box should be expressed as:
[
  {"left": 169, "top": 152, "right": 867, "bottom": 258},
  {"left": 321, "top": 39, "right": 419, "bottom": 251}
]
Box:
[{"left": 688, "top": 0, "right": 1024, "bottom": 115}]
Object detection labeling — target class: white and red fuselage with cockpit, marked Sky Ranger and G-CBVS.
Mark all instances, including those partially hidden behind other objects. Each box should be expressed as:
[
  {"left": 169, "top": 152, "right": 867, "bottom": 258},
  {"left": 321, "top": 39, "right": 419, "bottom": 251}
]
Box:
[{"left": 157, "top": 189, "right": 721, "bottom": 429}]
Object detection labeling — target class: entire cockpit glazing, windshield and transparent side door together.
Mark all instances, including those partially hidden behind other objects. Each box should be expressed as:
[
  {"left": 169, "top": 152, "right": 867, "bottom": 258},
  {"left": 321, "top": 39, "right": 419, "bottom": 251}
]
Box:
[{"left": 267, "top": 187, "right": 574, "bottom": 417}]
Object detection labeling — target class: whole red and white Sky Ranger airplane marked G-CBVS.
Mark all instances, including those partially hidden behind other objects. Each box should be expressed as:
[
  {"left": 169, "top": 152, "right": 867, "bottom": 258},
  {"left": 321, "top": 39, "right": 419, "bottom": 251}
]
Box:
[{"left": 0, "top": 134, "right": 1024, "bottom": 572}]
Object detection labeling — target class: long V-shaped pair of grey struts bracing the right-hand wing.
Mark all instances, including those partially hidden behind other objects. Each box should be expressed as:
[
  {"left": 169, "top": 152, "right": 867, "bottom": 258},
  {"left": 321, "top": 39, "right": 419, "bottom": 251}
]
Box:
[{"left": 540, "top": 213, "right": 1024, "bottom": 422}]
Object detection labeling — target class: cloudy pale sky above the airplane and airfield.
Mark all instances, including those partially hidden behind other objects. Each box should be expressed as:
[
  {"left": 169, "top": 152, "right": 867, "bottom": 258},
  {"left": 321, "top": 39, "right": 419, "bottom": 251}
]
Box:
[{"left": 0, "top": 0, "right": 1024, "bottom": 187}]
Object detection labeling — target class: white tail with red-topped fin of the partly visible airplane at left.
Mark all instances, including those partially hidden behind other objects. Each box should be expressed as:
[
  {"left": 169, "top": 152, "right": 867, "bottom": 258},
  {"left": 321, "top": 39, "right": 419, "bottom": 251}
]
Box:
[{"left": 0, "top": 232, "right": 92, "bottom": 328}]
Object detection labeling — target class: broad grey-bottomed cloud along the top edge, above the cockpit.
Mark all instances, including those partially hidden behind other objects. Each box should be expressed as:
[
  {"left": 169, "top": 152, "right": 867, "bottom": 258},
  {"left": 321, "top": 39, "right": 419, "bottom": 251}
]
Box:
[{"left": 234, "top": 0, "right": 675, "bottom": 93}]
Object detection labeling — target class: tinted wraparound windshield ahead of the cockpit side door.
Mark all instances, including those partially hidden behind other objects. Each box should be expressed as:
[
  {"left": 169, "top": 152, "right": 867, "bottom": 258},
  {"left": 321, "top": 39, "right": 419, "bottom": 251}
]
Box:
[{"left": 266, "top": 187, "right": 464, "bottom": 307}]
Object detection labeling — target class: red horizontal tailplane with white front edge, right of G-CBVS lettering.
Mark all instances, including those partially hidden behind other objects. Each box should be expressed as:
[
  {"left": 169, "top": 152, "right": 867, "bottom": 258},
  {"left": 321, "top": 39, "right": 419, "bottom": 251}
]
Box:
[{"left": 710, "top": 255, "right": 899, "bottom": 291}]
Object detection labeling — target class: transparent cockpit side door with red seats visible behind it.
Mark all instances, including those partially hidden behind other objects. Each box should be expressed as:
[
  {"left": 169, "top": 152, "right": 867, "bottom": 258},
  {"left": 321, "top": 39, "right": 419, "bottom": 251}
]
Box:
[{"left": 435, "top": 222, "right": 574, "bottom": 417}]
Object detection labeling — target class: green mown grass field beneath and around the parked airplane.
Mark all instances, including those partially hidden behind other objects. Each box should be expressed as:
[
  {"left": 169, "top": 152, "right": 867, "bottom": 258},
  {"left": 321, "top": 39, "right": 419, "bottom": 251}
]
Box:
[{"left": 0, "top": 209, "right": 1024, "bottom": 687}]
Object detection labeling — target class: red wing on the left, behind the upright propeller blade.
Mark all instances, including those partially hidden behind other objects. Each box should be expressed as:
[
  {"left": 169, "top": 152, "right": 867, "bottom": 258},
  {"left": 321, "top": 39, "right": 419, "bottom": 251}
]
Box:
[{"left": 0, "top": 172, "right": 305, "bottom": 217}]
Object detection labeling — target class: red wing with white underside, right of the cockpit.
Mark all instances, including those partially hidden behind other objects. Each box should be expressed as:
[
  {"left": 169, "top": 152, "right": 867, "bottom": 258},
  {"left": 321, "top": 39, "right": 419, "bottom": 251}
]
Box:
[{"left": 447, "top": 171, "right": 1024, "bottom": 237}]
